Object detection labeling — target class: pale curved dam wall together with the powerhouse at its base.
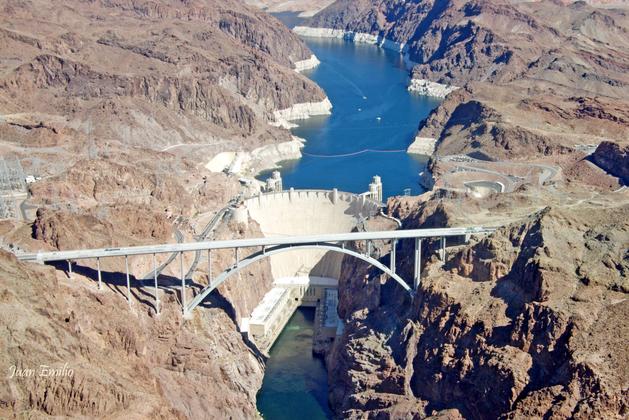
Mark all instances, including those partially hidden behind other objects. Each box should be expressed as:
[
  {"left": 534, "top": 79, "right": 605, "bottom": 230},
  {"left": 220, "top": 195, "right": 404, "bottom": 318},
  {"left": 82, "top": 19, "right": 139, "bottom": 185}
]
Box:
[{"left": 242, "top": 189, "right": 382, "bottom": 351}]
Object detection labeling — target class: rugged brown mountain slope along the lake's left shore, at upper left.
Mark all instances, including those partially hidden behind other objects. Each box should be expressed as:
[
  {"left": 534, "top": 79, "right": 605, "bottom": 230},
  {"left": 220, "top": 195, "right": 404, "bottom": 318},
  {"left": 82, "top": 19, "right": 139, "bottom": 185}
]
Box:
[{"left": 0, "top": 0, "right": 325, "bottom": 156}]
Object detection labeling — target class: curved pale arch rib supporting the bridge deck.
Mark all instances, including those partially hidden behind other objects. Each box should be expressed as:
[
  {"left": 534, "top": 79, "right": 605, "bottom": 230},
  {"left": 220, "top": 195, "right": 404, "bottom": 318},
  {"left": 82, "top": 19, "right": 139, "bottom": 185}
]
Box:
[{"left": 184, "top": 243, "right": 412, "bottom": 314}]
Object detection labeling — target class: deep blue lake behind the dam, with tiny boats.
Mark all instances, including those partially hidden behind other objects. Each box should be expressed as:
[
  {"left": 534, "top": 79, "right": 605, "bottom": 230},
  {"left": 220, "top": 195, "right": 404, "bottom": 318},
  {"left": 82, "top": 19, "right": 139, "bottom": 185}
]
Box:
[{"left": 260, "top": 38, "right": 439, "bottom": 198}]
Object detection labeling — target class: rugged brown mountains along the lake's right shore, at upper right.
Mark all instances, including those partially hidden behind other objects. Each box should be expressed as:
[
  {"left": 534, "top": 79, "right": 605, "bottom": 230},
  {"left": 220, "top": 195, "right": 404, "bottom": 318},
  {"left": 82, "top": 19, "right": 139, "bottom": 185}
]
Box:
[{"left": 307, "top": 0, "right": 629, "bottom": 159}]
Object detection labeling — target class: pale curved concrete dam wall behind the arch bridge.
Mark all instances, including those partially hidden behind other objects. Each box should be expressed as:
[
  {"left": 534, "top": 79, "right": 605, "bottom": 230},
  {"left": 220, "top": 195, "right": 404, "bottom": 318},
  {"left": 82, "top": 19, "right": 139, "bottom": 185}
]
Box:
[{"left": 244, "top": 190, "right": 380, "bottom": 280}]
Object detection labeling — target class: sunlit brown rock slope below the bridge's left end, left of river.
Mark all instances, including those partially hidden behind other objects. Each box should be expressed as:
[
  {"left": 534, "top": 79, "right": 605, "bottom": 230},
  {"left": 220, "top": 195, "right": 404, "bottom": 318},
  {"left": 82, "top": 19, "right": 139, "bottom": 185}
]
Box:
[{"left": 0, "top": 251, "right": 263, "bottom": 418}]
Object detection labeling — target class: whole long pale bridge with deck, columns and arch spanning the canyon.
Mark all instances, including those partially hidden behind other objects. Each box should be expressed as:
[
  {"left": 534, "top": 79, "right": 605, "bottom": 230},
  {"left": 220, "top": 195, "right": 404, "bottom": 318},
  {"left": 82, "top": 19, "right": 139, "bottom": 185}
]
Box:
[{"left": 17, "top": 226, "right": 495, "bottom": 316}]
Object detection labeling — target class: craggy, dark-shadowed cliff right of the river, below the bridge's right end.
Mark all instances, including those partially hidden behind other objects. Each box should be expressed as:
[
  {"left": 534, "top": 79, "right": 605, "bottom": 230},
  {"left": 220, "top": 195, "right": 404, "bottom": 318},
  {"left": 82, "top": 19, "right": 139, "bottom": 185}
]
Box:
[{"left": 328, "top": 195, "right": 629, "bottom": 418}]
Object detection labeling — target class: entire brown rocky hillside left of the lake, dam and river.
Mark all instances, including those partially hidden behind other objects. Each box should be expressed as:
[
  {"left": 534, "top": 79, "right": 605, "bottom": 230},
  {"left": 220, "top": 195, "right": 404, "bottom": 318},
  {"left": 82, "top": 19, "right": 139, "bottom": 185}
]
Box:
[{"left": 0, "top": 0, "right": 326, "bottom": 418}]
